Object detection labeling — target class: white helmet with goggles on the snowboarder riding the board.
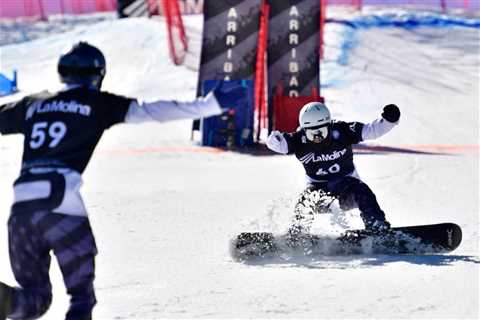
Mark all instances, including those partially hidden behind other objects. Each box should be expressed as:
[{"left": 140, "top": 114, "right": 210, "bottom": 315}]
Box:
[{"left": 298, "top": 102, "right": 332, "bottom": 143}]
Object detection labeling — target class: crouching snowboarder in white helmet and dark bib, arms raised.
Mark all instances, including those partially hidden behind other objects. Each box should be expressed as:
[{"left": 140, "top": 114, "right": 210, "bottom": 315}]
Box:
[{"left": 267, "top": 102, "right": 400, "bottom": 235}]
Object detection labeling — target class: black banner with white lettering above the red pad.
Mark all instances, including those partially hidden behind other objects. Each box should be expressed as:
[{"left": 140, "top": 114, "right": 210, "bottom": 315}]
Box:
[{"left": 267, "top": 0, "right": 320, "bottom": 99}]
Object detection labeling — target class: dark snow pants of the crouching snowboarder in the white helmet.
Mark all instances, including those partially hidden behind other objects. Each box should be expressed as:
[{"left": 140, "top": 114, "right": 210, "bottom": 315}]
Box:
[{"left": 295, "top": 177, "right": 385, "bottom": 227}]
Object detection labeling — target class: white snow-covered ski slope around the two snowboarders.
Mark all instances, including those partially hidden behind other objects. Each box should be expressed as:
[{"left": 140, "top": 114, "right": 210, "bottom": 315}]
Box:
[{"left": 0, "top": 11, "right": 480, "bottom": 319}]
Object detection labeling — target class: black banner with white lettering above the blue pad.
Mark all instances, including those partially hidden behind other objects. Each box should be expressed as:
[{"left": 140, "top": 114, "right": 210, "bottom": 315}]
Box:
[{"left": 197, "top": 0, "right": 261, "bottom": 95}]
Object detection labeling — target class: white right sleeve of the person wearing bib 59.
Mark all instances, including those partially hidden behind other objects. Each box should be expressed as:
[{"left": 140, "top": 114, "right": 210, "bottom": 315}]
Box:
[{"left": 125, "top": 92, "right": 222, "bottom": 123}]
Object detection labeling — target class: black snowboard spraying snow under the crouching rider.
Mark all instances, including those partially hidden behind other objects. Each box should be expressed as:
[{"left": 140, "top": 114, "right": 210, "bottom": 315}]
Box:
[{"left": 231, "top": 223, "right": 462, "bottom": 260}]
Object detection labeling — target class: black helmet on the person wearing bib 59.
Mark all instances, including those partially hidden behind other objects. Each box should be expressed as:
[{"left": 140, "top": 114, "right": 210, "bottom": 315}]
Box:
[{"left": 58, "top": 42, "right": 106, "bottom": 89}]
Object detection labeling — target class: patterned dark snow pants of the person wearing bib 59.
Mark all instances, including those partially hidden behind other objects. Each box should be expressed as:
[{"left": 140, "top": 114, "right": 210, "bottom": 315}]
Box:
[{"left": 8, "top": 211, "right": 97, "bottom": 320}]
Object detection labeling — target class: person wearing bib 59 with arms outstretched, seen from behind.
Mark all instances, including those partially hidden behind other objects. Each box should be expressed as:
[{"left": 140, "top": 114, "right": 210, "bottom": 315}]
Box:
[{"left": 0, "top": 42, "right": 245, "bottom": 320}]
